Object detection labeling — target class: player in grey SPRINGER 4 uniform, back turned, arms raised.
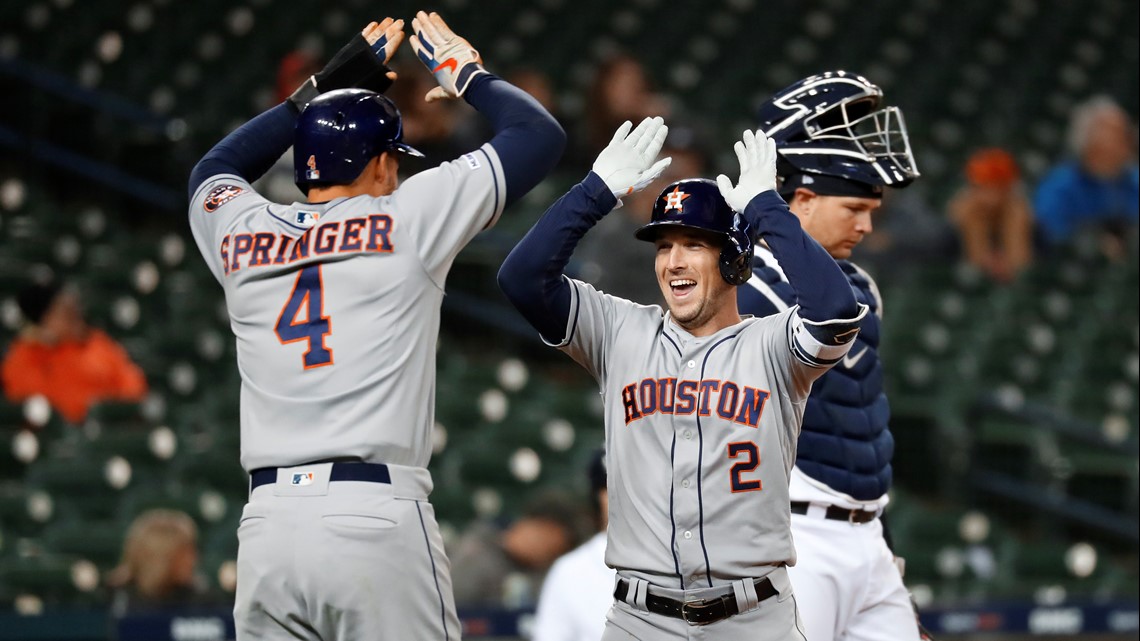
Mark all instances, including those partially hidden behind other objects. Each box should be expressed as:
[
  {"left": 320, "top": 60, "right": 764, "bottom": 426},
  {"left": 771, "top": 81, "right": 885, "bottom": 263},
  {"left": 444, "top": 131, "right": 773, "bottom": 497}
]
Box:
[{"left": 189, "top": 11, "right": 565, "bottom": 641}]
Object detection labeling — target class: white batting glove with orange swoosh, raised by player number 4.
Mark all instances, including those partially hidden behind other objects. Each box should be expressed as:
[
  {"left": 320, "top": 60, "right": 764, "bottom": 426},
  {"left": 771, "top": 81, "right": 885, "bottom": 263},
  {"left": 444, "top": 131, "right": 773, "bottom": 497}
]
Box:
[{"left": 409, "top": 11, "right": 487, "bottom": 103}]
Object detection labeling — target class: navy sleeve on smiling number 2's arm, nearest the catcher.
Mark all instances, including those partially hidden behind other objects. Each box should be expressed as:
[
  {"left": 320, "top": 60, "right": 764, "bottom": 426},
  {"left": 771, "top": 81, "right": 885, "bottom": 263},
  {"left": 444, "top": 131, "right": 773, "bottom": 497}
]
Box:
[{"left": 744, "top": 190, "right": 860, "bottom": 323}]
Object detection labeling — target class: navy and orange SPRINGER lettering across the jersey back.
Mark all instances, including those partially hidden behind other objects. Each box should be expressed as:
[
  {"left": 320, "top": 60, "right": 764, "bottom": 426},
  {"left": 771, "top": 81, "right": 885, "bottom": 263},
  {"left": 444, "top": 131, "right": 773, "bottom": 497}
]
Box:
[{"left": 220, "top": 213, "right": 392, "bottom": 276}]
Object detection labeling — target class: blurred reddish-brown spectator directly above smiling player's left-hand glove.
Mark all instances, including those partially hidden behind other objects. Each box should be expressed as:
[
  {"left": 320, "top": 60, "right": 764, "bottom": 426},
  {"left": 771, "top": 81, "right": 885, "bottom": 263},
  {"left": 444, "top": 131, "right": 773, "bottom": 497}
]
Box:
[{"left": 581, "top": 55, "right": 671, "bottom": 158}]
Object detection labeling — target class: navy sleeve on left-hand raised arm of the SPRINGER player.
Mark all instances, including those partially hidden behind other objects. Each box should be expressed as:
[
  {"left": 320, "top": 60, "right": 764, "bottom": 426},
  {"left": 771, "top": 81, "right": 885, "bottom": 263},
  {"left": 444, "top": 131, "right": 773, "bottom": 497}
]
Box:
[{"left": 189, "top": 103, "right": 296, "bottom": 198}]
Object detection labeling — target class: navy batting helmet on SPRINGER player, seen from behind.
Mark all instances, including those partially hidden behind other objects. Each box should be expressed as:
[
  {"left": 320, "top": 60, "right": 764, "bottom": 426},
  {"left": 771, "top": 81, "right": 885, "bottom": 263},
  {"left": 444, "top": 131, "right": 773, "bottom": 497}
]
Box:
[{"left": 293, "top": 89, "right": 423, "bottom": 192}]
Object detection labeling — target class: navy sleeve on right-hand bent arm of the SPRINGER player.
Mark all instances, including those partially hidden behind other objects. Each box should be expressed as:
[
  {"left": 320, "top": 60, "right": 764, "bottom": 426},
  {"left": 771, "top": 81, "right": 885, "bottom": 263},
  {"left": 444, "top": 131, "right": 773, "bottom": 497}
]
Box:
[{"left": 463, "top": 74, "right": 567, "bottom": 205}]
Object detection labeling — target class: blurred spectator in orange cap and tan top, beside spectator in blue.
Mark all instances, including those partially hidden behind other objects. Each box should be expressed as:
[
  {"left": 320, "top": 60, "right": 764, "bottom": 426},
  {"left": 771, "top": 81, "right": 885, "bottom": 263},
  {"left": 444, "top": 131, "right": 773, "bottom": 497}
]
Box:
[{"left": 948, "top": 148, "right": 1033, "bottom": 283}]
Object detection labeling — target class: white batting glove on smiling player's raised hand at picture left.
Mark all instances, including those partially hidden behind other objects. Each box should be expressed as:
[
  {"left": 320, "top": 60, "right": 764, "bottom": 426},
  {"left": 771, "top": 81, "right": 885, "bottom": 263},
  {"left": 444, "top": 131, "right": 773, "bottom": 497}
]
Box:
[{"left": 593, "top": 117, "right": 673, "bottom": 206}]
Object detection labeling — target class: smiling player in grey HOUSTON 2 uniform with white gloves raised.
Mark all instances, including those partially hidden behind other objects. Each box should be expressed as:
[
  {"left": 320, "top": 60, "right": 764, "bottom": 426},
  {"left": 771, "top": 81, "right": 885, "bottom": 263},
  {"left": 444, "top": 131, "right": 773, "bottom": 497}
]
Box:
[{"left": 498, "top": 119, "right": 866, "bottom": 641}]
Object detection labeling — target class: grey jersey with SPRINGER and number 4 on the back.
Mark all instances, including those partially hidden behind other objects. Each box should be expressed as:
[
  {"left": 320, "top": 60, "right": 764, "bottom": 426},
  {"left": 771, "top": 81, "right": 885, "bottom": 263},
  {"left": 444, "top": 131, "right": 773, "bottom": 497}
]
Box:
[{"left": 190, "top": 145, "right": 506, "bottom": 470}]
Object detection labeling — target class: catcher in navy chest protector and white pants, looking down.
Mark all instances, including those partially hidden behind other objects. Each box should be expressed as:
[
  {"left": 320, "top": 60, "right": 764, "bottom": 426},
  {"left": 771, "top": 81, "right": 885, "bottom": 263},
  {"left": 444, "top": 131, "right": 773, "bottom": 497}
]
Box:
[{"left": 740, "top": 72, "right": 919, "bottom": 641}]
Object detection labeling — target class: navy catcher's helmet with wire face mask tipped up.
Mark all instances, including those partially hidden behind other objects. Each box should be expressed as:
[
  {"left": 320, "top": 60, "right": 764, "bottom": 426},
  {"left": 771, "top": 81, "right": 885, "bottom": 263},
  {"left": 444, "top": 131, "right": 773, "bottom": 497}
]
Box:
[{"left": 757, "top": 71, "right": 919, "bottom": 187}]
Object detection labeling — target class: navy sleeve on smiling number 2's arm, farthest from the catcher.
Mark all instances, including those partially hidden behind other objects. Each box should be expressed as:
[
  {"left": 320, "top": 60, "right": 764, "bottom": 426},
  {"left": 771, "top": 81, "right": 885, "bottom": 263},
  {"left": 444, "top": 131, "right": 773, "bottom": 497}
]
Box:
[{"left": 498, "top": 172, "right": 617, "bottom": 343}]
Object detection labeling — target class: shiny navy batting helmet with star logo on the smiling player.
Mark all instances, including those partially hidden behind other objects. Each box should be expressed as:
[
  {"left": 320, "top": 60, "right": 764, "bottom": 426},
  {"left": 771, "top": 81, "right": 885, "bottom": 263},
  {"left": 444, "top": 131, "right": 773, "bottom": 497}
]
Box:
[{"left": 634, "top": 178, "right": 752, "bottom": 285}]
